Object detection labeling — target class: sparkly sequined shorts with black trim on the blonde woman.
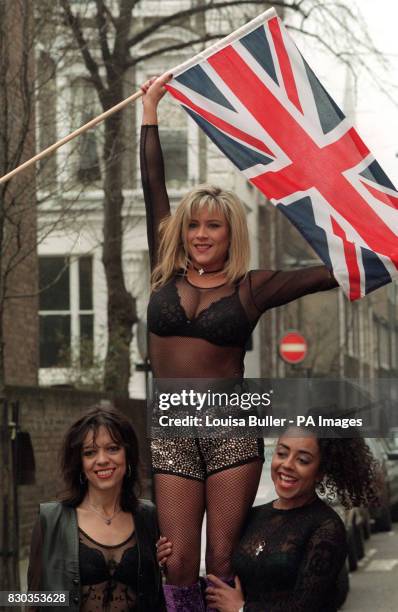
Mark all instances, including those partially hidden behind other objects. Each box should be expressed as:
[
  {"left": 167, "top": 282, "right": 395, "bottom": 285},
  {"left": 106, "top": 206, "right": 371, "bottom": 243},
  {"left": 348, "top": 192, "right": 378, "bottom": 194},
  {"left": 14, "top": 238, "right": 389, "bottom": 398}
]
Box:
[{"left": 151, "top": 438, "right": 264, "bottom": 480}]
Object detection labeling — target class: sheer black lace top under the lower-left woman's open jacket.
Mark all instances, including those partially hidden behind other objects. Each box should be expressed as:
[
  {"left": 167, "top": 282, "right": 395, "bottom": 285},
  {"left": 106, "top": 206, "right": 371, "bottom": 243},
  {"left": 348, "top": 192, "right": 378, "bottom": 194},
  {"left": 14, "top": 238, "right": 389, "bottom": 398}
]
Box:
[{"left": 79, "top": 528, "right": 138, "bottom": 612}]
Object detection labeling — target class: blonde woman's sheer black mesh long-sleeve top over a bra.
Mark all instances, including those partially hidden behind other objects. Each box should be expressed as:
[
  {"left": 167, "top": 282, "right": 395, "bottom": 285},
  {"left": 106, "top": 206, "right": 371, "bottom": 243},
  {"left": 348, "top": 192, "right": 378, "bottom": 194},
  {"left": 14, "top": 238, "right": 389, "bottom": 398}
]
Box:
[{"left": 141, "top": 125, "right": 337, "bottom": 378}]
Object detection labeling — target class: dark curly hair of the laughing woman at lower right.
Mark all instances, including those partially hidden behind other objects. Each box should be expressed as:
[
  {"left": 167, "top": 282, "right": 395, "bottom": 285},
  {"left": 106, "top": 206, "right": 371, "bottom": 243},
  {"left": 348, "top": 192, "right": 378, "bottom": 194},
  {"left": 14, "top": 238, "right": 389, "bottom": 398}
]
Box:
[{"left": 317, "top": 435, "right": 381, "bottom": 508}]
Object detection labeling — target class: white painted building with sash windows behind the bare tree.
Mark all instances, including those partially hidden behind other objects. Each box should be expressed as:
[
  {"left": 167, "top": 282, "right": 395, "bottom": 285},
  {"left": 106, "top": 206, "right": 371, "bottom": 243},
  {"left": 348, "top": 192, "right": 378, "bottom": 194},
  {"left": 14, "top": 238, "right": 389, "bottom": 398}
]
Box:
[{"left": 38, "top": 0, "right": 268, "bottom": 397}]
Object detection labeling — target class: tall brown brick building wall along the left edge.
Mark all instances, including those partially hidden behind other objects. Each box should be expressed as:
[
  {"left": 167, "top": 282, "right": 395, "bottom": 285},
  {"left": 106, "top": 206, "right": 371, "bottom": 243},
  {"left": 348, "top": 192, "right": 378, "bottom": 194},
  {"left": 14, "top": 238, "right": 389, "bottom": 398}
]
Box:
[{"left": 0, "top": 0, "right": 38, "bottom": 385}]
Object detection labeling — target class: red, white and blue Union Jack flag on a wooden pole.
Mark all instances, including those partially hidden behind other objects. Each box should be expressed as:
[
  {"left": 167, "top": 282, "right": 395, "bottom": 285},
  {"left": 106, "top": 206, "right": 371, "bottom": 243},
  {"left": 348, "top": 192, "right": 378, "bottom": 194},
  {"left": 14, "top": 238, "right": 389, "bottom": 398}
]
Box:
[{"left": 167, "top": 9, "right": 398, "bottom": 300}]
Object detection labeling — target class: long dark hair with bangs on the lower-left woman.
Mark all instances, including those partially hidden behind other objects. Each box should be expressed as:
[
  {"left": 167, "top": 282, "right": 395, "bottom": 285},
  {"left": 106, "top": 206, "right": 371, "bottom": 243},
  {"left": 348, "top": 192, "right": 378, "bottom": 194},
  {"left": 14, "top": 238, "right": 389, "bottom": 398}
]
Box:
[{"left": 58, "top": 405, "right": 139, "bottom": 512}]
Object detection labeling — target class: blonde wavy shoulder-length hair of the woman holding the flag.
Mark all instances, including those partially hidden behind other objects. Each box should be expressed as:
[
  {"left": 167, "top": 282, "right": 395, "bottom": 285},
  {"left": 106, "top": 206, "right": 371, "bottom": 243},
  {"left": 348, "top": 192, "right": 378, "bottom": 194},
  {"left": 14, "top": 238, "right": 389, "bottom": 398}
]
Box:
[{"left": 152, "top": 185, "right": 250, "bottom": 290}]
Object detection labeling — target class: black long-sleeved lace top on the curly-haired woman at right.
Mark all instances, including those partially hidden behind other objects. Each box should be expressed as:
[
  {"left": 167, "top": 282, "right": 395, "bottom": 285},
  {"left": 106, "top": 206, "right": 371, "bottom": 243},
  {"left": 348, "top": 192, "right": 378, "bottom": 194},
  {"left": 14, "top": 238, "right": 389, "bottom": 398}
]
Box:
[{"left": 232, "top": 499, "right": 346, "bottom": 612}]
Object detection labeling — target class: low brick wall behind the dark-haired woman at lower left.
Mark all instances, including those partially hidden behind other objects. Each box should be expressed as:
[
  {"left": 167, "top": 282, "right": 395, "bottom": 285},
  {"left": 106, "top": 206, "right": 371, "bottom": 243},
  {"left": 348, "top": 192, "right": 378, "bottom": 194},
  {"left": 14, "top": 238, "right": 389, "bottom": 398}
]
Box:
[{"left": 7, "top": 387, "right": 150, "bottom": 558}]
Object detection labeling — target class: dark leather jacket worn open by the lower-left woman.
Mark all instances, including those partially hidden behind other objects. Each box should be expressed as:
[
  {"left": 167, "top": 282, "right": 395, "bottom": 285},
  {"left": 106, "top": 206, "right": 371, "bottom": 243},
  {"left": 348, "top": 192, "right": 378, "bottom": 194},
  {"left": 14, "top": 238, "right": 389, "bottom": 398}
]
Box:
[{"left": 28, "top": 500, "right": 166, "bottom": 612}]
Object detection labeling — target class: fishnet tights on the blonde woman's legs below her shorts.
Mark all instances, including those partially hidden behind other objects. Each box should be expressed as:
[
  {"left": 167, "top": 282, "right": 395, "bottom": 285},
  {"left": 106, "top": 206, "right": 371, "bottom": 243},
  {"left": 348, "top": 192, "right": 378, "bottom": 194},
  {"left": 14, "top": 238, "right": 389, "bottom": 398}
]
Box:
[{"left": 155, "top": 460, "right": 262, "bottom": 586}]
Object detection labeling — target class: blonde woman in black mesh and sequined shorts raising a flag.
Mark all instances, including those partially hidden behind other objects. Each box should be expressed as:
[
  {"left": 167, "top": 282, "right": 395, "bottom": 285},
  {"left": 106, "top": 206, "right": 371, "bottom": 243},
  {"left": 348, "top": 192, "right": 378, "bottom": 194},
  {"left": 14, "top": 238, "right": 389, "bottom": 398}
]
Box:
[{"left": 141, "top": 76, "right": 336, "bottom": 612}]
